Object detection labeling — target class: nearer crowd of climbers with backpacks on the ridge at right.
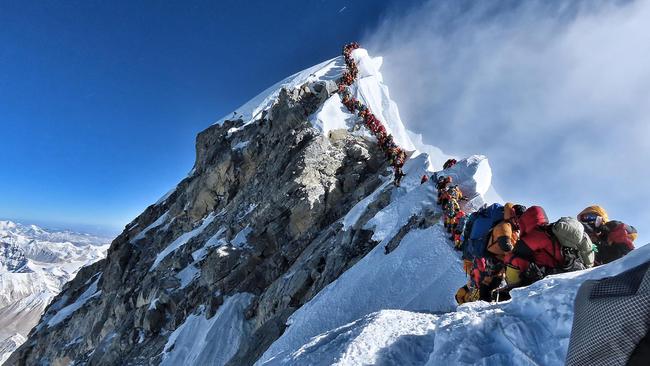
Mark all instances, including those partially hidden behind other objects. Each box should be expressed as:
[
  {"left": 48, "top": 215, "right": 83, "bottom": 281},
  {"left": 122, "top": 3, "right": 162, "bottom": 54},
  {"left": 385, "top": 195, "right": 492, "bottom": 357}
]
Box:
[{"left": 422, "top": 159, "right": 637, "bottom": 304}]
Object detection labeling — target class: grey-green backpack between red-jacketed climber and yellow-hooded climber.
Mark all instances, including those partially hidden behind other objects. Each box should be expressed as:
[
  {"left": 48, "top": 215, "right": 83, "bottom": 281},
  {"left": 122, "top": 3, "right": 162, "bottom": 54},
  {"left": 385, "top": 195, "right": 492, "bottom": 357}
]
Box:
[{"left": 551, "top": 217, "right": 594, "bottom": 268}]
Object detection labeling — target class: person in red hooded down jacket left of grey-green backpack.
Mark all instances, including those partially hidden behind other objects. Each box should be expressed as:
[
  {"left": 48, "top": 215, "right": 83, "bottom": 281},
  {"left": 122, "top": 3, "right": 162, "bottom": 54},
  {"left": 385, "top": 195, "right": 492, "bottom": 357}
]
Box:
[{"left": 505, "top": 206, "right": 564, "bottom": 288}]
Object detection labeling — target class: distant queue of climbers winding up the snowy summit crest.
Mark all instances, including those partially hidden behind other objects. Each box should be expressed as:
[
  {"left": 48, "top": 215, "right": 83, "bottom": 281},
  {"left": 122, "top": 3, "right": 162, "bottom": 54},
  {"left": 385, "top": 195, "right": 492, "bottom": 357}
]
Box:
[{"left": 337, "top": 42, "right": 407, "bottom": 187}]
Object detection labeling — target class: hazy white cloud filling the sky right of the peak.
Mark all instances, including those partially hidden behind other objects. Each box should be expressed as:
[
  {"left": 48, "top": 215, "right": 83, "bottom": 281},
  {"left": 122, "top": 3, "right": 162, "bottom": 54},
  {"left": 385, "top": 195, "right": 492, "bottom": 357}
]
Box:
[{"left": 365, "top": 0, "right": 650, "bottom": 241}]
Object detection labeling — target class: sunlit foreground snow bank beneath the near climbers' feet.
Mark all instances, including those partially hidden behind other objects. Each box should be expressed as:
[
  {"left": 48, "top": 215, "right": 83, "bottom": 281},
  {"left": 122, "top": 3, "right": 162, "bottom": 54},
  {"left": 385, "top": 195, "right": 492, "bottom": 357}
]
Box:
[{"left": 264, "top": 245, "right": 650, "bottom": 365}]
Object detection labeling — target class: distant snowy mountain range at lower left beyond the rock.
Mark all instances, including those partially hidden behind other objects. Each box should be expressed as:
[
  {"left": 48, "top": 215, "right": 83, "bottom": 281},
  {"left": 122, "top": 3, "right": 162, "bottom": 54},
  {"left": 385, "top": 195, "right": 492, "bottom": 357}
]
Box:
[{"left": 0, "top": 221, "right": 110, "bottom": 364}]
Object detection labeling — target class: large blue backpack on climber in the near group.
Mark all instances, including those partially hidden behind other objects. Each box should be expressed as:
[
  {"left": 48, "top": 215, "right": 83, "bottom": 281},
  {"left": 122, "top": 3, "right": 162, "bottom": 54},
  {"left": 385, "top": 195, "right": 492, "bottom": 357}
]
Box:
[{"left": 461, "top": 203, "right": 503, "bottom": 260}]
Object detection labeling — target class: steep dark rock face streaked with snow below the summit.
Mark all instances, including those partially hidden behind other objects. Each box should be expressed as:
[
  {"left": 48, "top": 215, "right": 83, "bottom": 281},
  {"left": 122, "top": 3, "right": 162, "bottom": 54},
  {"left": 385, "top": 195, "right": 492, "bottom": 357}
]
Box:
[{"left": 7, "top": 77, "right": 398, "bottom": 365}]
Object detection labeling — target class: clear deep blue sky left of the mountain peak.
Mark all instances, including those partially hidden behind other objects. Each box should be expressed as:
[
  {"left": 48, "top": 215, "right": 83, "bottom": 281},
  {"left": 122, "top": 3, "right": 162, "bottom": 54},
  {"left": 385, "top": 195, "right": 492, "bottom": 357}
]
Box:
[{"left": 0, "top": 0, "right": 415, "bottom": 234}]
